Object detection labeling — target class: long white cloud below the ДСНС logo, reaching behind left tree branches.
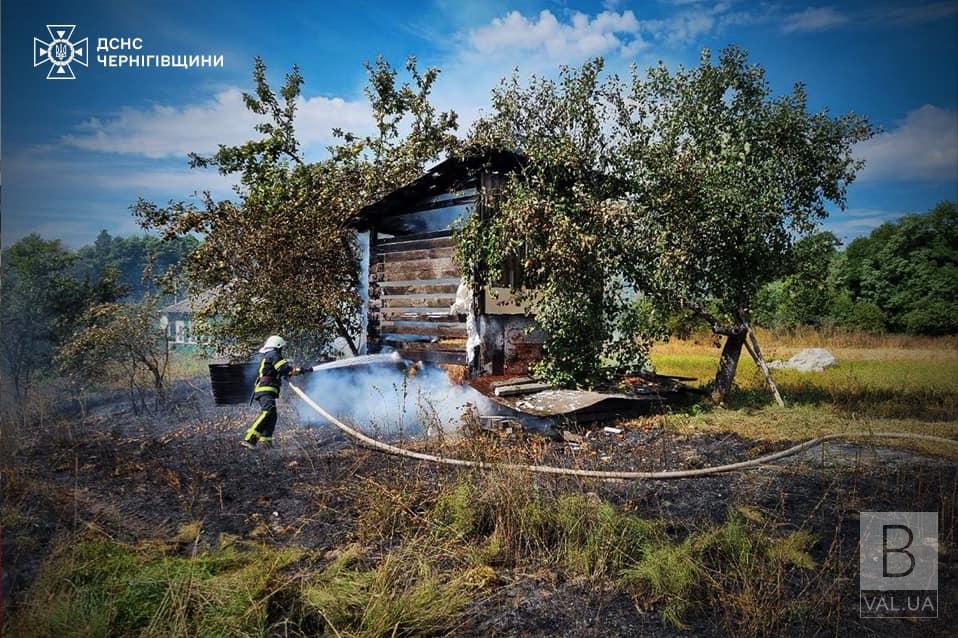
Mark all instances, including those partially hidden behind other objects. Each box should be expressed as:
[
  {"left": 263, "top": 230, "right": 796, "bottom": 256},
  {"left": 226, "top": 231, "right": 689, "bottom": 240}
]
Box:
[{"left": 61, "top": 88, "right": 372, "bottom": 159}]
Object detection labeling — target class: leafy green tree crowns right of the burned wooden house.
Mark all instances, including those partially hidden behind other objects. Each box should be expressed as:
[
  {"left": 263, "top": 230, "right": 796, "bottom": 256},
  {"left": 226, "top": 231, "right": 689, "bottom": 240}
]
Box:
[{"left": 458, "top": 47, "right": 874, "bottom": 387}]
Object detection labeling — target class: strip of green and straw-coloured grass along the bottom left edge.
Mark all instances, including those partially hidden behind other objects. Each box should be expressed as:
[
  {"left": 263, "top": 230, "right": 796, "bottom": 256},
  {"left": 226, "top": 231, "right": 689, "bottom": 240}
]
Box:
[{"left": 5, "top": 538, "right": 472, "bottom": 638}]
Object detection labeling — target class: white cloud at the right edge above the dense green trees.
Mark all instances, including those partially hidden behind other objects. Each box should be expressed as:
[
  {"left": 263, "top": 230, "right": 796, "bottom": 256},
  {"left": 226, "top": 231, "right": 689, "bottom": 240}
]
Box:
[{"left": 855, "top": 104, "right": 958, "bottom": 181}]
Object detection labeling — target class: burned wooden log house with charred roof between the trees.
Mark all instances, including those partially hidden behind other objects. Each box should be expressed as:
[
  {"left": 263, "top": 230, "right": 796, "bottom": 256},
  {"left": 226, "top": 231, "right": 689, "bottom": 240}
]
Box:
[{"left": 355, "top": 152, "right": 542, "bottom": 376}]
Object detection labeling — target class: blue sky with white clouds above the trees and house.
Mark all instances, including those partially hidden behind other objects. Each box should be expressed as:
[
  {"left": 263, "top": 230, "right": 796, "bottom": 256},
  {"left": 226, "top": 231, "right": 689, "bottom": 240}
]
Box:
[{"left": 0, "top": 0, "right": 958, "bottom": 247}]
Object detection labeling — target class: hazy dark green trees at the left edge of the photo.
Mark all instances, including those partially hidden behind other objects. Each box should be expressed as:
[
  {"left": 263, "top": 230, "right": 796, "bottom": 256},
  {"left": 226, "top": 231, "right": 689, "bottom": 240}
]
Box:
[{"left": 0, "top": 231, "right": 197, "bottom": 399}]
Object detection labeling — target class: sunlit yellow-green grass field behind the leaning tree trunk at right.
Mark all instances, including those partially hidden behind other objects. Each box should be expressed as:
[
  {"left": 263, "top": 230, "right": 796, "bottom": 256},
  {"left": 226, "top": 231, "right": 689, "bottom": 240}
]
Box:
[{"left": 652, "top": 332, "right": 958, "bottom": 455}]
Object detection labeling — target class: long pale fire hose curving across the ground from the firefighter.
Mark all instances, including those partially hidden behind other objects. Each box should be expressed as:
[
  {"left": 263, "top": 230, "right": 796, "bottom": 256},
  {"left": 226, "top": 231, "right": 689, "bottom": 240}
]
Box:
[{"left": 289, "top": 383, "right": 958, "bottom": 480}]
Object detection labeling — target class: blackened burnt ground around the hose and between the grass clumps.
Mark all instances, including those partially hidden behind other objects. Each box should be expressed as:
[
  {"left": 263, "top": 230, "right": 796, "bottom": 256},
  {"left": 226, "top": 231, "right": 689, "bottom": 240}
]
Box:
[{"left": 3, "top": 384, "right": 958, "bottom": 636}]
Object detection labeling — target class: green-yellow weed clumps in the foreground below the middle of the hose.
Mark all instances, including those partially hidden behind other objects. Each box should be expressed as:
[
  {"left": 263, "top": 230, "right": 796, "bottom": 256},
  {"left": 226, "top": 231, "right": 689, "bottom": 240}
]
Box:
[{"left": 430, "top": 475, "right": 816, "bottom": 635}]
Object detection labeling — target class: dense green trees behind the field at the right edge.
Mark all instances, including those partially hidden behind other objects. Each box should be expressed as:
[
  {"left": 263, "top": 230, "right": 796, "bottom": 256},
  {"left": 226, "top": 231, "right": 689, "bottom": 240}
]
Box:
[{"left": 753, "top": 201, "right": 958, "bottom": 335}]
